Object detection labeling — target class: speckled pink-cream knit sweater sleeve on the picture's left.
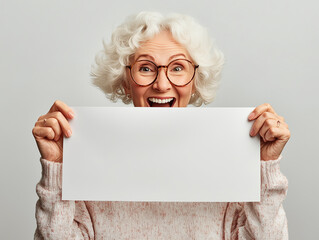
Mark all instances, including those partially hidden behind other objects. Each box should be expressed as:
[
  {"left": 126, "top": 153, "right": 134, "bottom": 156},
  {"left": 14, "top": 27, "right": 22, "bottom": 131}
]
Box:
[{"left": 34, "top": 158, "right": 94, "bottom": 239}]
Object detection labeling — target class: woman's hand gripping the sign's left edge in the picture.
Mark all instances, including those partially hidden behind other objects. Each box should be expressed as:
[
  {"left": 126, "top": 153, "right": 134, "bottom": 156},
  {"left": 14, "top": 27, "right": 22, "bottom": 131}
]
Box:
[{"left": 32, "top": 100, "right": 74, "bottom": 162}]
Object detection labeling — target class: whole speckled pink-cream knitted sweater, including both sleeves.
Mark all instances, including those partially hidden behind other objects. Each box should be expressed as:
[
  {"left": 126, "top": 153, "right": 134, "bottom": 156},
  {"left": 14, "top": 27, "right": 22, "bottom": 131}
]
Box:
[{"left": 34, "top": 156, "right": 288, "bottom": 240}]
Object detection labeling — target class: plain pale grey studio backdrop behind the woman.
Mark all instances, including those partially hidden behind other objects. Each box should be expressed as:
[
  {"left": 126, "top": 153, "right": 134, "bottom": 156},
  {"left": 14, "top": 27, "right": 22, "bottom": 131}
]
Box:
[{"left": 0, "top": 0, "right": 319, "bottom": 239}]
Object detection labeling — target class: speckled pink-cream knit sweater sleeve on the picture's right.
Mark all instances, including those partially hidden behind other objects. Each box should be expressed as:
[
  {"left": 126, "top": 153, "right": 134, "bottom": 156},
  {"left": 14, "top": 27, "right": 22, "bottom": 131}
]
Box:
[{"left": 227, "top": 155, "right": 288, "bottom": 240}]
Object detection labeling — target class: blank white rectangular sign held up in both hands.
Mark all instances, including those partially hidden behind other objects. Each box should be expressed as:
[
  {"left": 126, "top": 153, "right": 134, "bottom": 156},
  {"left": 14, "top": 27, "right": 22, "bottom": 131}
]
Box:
[{"left": 62, "top": 107, "right": 260, "bottom": 202}]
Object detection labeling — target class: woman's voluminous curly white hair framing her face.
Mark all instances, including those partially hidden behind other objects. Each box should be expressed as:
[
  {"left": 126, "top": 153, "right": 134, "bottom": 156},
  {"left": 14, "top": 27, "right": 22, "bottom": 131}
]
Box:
[{"left": 91, "top": 12, "right": 224, "bottom": 106}]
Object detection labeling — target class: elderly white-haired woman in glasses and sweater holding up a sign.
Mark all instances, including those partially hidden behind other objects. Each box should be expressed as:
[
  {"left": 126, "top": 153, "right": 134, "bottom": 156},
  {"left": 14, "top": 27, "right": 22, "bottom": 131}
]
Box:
[{"left": 33, "top": 12, "right": 290, "bottom": 239}]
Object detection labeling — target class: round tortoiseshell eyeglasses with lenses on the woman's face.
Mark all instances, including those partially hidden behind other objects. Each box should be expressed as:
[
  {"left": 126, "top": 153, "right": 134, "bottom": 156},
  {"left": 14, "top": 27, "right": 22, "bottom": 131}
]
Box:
[{"left": 126, "top": 59, "right": 199, "bottom": 87}]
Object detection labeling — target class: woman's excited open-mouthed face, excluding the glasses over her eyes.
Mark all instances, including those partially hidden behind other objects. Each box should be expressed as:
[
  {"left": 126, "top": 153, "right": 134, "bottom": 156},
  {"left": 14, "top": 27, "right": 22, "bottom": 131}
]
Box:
[{"left": 125, "top": 31, "right": 195, "bottom": 107}]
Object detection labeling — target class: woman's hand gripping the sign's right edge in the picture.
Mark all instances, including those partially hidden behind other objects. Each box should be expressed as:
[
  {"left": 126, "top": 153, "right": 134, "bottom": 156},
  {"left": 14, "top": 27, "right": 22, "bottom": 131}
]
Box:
[{"left": 248, "top": 103, "right": 290, "bottom": 161}]
